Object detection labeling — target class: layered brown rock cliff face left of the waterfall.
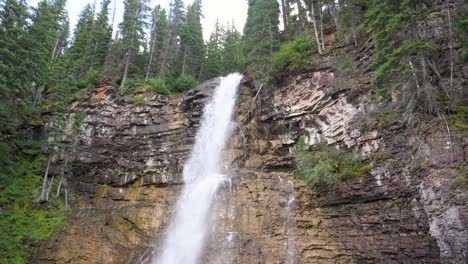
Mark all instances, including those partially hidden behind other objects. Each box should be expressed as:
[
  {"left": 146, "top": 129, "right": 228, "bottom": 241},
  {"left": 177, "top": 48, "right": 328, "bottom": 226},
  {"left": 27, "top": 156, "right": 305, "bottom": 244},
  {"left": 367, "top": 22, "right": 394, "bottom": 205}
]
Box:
[{"left": 31, "top": 80, "right": 218, "bottom": 263}]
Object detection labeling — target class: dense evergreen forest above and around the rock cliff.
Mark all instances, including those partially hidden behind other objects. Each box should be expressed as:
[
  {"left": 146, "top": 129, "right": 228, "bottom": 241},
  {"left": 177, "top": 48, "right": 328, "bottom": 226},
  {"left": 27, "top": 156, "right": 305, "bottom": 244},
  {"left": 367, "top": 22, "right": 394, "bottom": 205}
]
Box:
[{"left": 0, "top": 0, "right": 468, "bottom": 263}]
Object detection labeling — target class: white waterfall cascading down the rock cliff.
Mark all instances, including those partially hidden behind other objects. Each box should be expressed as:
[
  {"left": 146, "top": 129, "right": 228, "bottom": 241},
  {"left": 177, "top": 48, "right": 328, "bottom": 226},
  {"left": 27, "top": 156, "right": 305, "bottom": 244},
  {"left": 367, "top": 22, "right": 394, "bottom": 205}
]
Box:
[{"left": 153, "top": 73, "right": 242, "bottom": 264}]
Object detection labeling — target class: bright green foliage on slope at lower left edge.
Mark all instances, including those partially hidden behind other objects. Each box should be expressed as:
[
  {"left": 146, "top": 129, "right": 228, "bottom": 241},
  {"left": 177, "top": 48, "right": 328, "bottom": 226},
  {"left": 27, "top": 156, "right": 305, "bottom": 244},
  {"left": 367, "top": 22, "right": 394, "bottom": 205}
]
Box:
[{"left": 0, "top": 141, "right": 66, "bottom": 263}]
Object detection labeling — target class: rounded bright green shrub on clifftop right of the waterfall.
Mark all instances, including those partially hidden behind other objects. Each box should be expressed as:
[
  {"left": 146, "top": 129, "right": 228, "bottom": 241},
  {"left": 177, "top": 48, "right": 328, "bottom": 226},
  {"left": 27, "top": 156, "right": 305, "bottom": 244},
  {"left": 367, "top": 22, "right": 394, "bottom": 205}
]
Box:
[{"left": 273, "top": 35, "right": 316, "bottom": 74}]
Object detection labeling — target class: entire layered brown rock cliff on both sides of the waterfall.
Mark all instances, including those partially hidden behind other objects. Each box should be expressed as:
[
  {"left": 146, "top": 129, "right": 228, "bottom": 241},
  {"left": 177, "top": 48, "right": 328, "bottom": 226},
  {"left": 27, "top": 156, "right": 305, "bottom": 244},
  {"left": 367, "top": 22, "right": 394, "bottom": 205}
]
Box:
[{"left": 31, "top": 5, "right": 468, "bottom": 263}]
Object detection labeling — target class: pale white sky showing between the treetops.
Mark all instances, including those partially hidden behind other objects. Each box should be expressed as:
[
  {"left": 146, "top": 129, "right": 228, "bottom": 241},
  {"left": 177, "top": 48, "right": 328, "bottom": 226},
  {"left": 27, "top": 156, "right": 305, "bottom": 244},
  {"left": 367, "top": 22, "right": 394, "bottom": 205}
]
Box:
[{"left": 28, "top": 0, "right": 247, "bottom": 40}]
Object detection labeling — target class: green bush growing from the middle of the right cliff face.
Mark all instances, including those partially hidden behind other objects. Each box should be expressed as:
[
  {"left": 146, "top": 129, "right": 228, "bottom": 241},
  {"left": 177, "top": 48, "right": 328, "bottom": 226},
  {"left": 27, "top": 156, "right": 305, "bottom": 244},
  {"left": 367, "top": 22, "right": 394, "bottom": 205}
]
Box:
[{"left": 295, "top": 140, "right": 372, "bottom": 188}]
